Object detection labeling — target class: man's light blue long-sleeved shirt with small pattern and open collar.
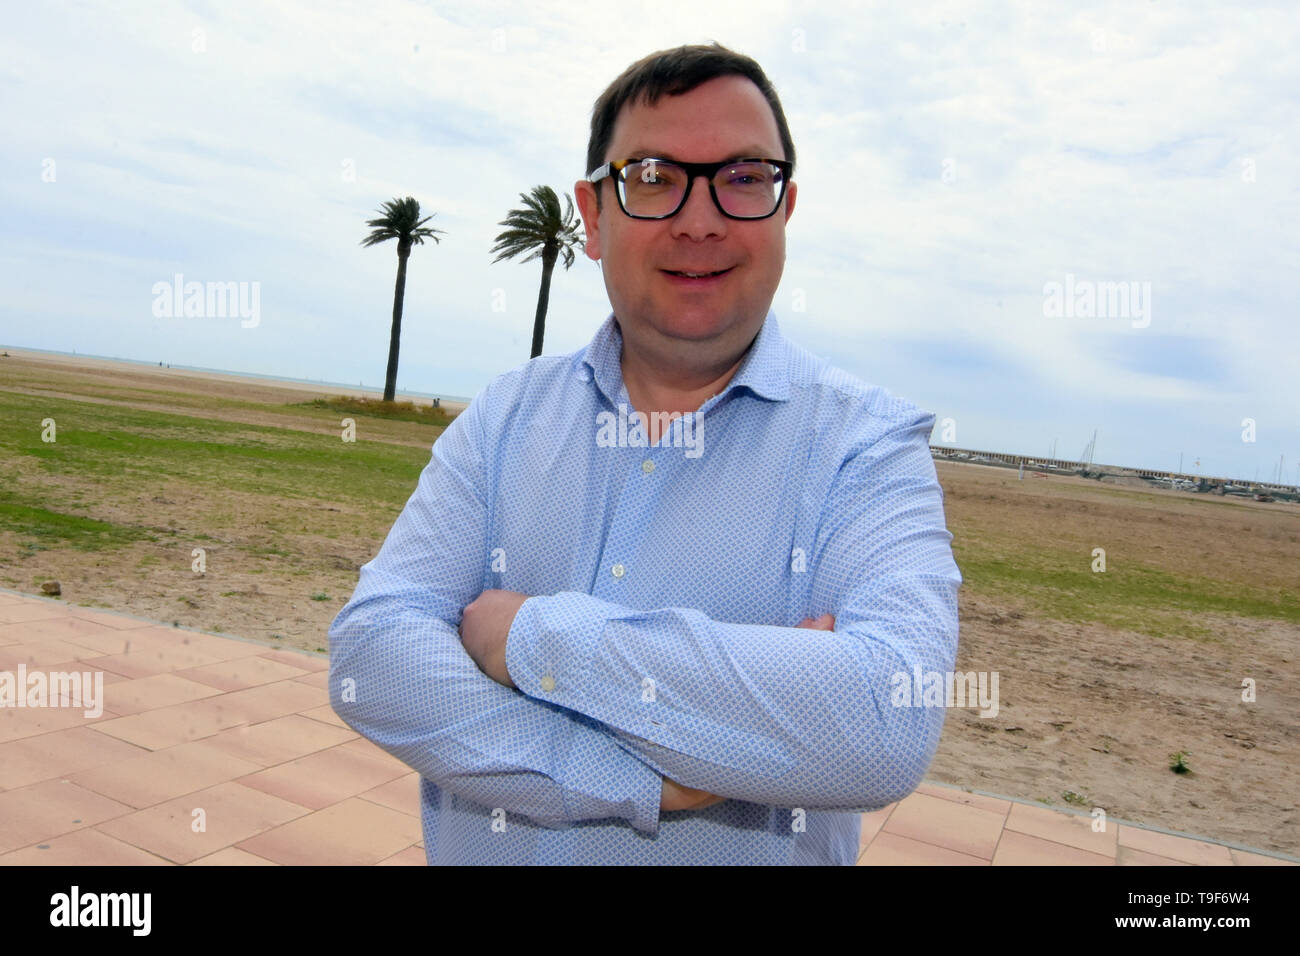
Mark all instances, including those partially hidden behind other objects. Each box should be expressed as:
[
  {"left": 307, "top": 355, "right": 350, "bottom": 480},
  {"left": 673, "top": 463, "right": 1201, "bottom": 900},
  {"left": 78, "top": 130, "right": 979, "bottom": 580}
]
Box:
[{"left": 330, "top": 313, "right": 961, "bottom": 865}]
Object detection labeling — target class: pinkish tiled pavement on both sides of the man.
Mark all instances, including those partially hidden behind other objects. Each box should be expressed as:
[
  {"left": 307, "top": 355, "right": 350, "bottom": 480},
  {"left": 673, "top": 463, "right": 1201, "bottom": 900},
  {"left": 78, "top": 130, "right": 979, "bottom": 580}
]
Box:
[{"left": 0, "top": 591, "right": 1295, "bottom": 866}]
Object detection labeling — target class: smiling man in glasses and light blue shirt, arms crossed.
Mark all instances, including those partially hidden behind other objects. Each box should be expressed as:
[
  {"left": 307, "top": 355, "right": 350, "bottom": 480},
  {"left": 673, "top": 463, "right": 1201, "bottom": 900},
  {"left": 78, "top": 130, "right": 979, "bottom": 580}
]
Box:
[{"left": 330, "top": 44, "right": 961, "bottom": 864}]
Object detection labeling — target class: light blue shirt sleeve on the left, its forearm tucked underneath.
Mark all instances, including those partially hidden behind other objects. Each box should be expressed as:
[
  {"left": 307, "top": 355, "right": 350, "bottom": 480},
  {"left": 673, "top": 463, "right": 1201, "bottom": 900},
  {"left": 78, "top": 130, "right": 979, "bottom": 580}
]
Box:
[{"left": 329, "top": 390, "right": 662, "bottom": 834}]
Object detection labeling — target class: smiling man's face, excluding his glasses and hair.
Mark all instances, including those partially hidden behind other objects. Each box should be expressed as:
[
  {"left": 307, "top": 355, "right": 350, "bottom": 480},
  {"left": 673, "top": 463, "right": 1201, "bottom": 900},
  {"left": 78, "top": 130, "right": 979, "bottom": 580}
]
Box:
[{"left": 575, "top": 75, "right": 796, "bottom": 362}]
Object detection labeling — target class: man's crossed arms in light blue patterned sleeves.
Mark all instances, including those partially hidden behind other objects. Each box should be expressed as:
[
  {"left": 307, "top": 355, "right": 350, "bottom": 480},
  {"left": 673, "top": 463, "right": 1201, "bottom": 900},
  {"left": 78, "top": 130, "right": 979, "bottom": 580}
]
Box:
[{"left": 330, "top": 385, "right": 959, "bottom": 832}]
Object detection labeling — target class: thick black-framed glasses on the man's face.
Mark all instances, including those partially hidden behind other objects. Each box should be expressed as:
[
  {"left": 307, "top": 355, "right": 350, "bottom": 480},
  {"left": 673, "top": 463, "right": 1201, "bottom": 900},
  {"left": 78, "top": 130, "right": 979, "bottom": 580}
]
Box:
[{"left": 586, "top": 157, "right": 792, "bottom": 220}]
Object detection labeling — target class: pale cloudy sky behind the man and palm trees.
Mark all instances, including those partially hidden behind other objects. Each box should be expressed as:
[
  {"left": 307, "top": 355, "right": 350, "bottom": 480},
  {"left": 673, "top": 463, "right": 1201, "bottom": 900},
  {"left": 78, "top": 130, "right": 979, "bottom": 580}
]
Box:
[{"left": 0, "top": 0, "right": 1300, "bottom": 481}]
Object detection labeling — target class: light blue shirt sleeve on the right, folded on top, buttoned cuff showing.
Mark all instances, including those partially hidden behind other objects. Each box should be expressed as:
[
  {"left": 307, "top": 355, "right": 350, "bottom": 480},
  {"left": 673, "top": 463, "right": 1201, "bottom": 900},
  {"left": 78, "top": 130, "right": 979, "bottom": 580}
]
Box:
[{"left": 507, "top": 412, "right": 961, "bottom": 810}]
